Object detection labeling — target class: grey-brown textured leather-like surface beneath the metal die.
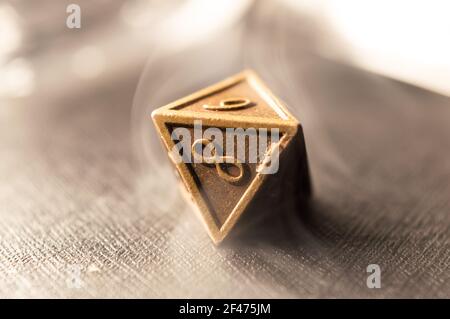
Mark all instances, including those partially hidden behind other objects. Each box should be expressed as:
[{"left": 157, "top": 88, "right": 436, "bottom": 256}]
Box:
[{"left": 0, "top": 1, "right": 450, "bottom": 298}]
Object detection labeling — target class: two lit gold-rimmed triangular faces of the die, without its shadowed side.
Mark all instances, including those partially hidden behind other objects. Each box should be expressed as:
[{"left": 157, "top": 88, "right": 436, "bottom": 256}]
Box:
[{"left": 152, "top": 71, "right": 299, "bottom": 243}]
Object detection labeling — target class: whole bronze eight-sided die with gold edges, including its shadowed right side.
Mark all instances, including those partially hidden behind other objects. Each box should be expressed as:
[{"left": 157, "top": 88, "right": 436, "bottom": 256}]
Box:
[{"left": 152, "top": 70, "right": 310, "bottom": 244}]
